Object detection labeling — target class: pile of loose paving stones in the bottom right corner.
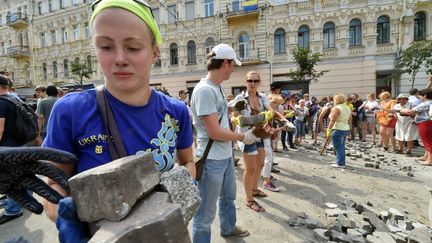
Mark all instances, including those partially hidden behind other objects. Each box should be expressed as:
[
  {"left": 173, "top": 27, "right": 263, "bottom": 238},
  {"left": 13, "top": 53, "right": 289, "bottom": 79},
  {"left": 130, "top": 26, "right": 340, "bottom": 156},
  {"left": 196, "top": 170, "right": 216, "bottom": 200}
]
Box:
[{"left": 288, "top": 200, "right": 432, "bottom": 243}]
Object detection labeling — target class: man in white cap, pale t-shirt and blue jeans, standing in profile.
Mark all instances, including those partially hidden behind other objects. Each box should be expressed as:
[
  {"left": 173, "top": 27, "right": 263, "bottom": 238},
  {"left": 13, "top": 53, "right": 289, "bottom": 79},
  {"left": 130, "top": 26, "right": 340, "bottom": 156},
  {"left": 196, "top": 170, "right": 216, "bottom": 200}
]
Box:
[{"left": 191, "top": 44, "right": 259, "bottom": 243}]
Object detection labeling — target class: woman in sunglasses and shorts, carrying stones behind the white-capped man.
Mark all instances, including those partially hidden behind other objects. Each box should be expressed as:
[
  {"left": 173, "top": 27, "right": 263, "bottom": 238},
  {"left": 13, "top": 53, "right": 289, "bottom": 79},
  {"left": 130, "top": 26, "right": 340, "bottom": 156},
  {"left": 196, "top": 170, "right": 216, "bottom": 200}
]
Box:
[{"left": 233, "top": 71, "right": 273, "bottom": 212}]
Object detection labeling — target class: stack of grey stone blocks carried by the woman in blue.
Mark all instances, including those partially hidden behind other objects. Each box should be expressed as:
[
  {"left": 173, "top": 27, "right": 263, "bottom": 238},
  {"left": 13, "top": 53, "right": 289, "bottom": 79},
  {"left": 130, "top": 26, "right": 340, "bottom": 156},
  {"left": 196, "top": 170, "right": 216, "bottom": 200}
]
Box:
[{"left": 69, "top": 154, "right": 200, "bottom": 243}]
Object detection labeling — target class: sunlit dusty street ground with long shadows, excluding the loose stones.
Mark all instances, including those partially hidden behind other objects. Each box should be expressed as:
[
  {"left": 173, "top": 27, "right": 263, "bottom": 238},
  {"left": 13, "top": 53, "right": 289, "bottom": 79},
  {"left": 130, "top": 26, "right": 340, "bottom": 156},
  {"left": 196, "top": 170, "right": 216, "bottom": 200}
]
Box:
[{"left": 0, "top": 136, "right": 432, "bottom": 243}]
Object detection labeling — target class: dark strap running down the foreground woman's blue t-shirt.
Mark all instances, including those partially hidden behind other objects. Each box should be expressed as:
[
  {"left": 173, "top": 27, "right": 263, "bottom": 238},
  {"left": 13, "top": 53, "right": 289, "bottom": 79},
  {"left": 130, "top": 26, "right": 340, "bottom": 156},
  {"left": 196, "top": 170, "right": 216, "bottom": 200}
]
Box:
[{"left": 96, "top": 85, "right": 128, "bottom": 160}]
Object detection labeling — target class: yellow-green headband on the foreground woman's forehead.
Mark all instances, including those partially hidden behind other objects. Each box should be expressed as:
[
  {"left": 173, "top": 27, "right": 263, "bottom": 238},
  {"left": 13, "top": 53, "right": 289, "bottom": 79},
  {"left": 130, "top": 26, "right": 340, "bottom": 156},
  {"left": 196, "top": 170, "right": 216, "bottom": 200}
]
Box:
[{"left": 90, "top": 0, "right": 162, "bottom": 46}]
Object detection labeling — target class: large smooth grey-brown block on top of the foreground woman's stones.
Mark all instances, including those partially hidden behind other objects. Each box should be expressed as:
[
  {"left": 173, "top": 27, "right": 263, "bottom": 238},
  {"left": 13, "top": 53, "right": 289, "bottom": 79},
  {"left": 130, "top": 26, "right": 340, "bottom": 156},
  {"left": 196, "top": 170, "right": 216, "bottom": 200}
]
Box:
[{"left": 69, "top": 154, "right": 159, "bottom": 222}]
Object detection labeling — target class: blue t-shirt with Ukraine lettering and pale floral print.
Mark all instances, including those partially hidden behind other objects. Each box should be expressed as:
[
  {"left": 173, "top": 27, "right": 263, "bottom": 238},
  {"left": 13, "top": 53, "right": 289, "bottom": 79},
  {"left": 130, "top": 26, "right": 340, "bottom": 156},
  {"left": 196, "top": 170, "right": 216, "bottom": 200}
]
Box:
[{"left": 43, "top": 89, "right": 193, "bottom": 173}]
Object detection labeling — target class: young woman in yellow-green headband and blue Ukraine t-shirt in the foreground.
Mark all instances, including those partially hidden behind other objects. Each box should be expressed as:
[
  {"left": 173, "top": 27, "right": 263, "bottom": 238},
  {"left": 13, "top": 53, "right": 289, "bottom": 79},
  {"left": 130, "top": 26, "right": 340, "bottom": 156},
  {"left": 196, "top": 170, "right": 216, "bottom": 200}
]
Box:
[{"left": 43, "top": 0, "right": 195, "bottom": 242}]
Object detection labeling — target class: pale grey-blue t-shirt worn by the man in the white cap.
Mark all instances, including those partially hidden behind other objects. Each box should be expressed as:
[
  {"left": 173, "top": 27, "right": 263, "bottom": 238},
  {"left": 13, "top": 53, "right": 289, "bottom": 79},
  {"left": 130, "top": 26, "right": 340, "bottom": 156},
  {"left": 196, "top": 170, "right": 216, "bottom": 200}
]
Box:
[{"left": 191, "top": 77, "right": 232, "bottom": 160}]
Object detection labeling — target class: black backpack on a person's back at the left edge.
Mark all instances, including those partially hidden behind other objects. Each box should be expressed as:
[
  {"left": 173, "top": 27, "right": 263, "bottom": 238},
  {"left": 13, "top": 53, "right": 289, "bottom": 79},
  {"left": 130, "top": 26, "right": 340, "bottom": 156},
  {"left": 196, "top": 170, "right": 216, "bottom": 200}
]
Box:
[{"left": 0, "top": 95, "right": 39, "bottom": 144}]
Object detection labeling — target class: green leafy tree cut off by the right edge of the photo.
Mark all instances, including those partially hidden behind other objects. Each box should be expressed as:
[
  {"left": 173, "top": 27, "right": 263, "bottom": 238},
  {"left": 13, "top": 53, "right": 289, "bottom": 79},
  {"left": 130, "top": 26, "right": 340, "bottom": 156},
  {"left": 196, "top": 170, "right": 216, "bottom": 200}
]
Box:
[{"left": 393, "top": 40, "right": 432, "bottom": 88}]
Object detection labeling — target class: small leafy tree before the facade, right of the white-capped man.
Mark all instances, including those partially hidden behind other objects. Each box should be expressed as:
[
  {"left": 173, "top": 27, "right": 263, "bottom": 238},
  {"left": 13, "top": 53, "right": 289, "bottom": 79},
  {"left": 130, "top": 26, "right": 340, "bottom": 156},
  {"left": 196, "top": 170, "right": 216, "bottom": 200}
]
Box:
[{"left": 288, "top": 47, "right": 328, "bottom": 82}]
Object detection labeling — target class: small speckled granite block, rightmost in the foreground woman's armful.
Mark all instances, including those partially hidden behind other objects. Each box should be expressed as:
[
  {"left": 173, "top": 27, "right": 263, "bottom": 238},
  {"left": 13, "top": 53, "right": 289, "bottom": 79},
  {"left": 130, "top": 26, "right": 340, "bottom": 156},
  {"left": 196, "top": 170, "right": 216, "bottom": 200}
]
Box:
[{"left": 160, "top": 166, "right": 201, "bottom": 224}]
